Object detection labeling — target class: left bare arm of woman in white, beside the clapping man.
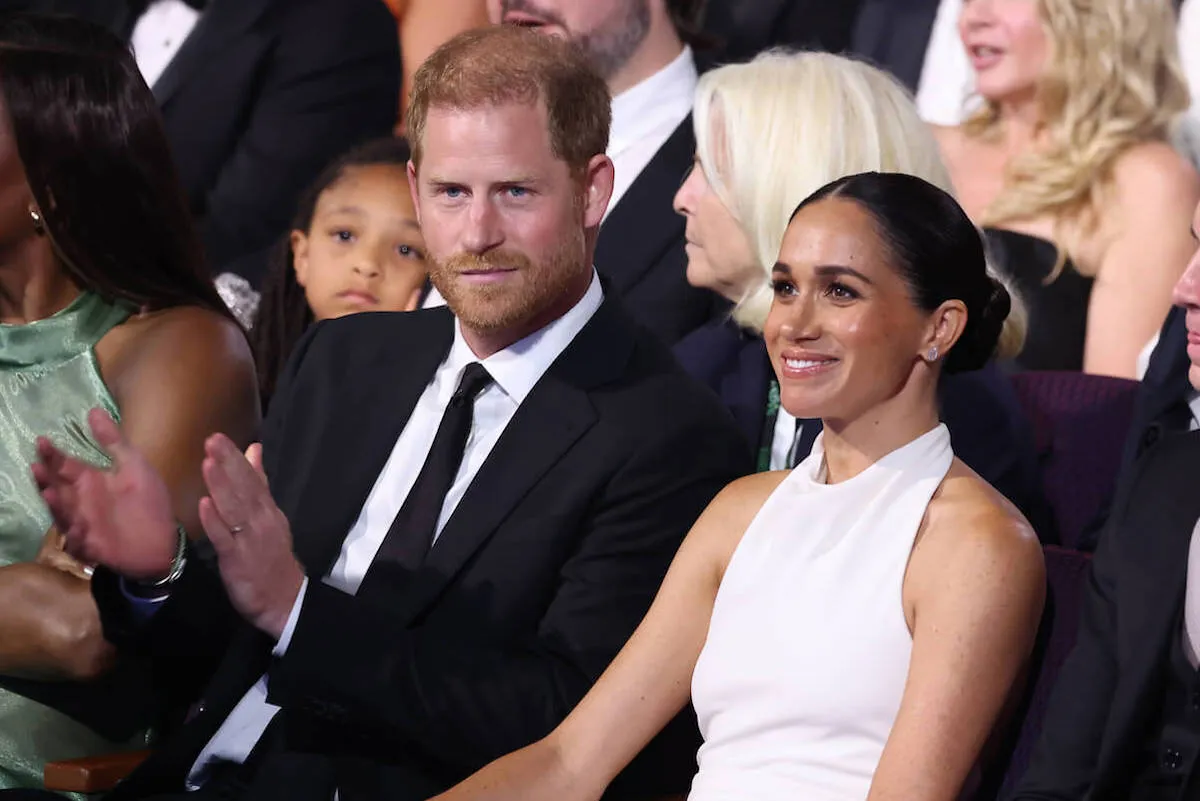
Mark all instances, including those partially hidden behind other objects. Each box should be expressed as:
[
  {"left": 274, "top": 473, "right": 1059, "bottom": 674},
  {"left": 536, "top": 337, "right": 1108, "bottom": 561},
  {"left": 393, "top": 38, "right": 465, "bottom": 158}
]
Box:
[{"left": 438, "top": 474, "right": 779, "bottom": 801}]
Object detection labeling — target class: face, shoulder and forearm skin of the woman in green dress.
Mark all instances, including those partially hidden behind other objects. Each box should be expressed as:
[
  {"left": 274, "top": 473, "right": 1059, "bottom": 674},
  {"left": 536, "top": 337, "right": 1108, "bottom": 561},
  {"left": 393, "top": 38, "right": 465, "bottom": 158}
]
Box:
[{"left": 0, "top": 95, "right": 258, "bottom": 680}]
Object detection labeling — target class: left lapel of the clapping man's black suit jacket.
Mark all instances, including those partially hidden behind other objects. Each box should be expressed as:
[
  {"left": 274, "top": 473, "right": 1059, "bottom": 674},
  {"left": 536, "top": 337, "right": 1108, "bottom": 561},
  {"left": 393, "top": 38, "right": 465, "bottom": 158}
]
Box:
[{"left": 288, "top": 309, "right": 454, "bottom": 576}]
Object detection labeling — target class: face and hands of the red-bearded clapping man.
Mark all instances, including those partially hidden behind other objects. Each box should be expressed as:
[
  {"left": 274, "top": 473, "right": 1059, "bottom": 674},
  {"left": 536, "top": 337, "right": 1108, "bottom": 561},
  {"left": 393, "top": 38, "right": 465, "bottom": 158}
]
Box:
[{"left": 36, "top": 94, "right": 613, "bottom": 639}]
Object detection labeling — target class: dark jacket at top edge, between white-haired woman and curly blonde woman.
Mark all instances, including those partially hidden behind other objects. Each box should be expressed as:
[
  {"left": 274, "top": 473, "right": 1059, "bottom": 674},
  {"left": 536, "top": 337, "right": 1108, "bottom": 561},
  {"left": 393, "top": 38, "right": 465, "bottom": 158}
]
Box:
[{"left": 850, "top": 0, "right": 938, "bottom": 91}]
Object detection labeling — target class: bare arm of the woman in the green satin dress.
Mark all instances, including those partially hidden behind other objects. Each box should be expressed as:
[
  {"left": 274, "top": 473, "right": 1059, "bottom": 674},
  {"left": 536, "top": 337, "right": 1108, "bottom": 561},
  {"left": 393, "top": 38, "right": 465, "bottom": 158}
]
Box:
[{"left": 0, "top": 309, "right": 258, "bottom": 680}]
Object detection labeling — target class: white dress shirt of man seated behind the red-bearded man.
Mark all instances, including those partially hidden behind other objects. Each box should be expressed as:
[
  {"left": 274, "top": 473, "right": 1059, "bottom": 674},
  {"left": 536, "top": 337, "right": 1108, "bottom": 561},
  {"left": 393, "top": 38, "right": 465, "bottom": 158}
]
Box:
[{"left": 605, "top": 47, "right": 698, "bottom": 215}]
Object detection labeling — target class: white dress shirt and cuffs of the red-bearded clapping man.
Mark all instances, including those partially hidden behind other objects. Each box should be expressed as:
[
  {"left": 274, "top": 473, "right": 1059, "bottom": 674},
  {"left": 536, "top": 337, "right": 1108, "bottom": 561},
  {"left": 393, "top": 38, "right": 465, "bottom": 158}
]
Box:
[{"left": 187, "top": 272, "right": 604, "bottom": 789}]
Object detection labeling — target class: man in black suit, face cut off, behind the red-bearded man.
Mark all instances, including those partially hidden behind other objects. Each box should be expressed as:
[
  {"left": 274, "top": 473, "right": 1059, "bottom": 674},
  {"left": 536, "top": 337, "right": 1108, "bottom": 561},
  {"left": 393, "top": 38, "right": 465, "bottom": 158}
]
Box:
[{"left": 488, "top": 0, "right": 721, "bottom": 344}]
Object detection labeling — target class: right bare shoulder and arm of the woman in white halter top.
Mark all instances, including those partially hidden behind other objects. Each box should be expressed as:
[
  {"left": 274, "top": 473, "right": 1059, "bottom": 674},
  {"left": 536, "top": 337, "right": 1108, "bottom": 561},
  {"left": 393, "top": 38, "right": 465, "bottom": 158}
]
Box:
[{"left": 868, "top": 478, "right": 1045, "bottom": 801}]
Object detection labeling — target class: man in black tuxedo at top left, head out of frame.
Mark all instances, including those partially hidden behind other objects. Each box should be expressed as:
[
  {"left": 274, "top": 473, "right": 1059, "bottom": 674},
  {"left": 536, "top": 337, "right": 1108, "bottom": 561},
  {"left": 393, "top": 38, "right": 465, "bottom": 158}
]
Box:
[{"left": 14, "top": 0, "right": 400, "bottom": 285}]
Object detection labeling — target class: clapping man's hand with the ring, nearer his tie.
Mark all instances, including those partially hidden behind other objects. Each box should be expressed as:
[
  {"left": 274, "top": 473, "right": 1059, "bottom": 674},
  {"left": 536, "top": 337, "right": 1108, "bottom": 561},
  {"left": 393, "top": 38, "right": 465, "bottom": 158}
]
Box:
[{"left": 200, "top": 434, "right": 305, "bottom": 640}]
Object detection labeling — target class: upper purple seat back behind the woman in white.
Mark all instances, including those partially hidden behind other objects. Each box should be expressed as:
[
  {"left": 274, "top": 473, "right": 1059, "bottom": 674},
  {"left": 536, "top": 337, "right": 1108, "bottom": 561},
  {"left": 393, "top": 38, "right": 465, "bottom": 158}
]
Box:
[{"left": 1012, "top": 372, "right": 1138, "bottom": 548}]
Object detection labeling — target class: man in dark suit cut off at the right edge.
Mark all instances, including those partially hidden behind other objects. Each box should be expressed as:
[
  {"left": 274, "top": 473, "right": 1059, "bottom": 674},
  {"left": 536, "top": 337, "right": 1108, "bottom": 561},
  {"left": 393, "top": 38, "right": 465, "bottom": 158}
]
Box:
[{"left": 1014, "top": 203, "right": 1200, "bottom": 801}]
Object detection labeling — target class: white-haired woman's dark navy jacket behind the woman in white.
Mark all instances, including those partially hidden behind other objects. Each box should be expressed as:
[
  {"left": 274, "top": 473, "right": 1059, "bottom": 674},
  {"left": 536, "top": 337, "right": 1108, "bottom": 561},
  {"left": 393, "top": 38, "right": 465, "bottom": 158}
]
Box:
[{"left": 674, "top": 320, "right": 1055, "bottom": 540}]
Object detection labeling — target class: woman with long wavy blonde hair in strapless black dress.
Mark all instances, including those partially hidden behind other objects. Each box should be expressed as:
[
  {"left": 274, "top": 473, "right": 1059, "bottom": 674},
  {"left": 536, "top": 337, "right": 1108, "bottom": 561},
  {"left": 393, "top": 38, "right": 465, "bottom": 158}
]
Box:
[{"left": 937, "top": 0, "right": 1200, "bottom": 378}]
